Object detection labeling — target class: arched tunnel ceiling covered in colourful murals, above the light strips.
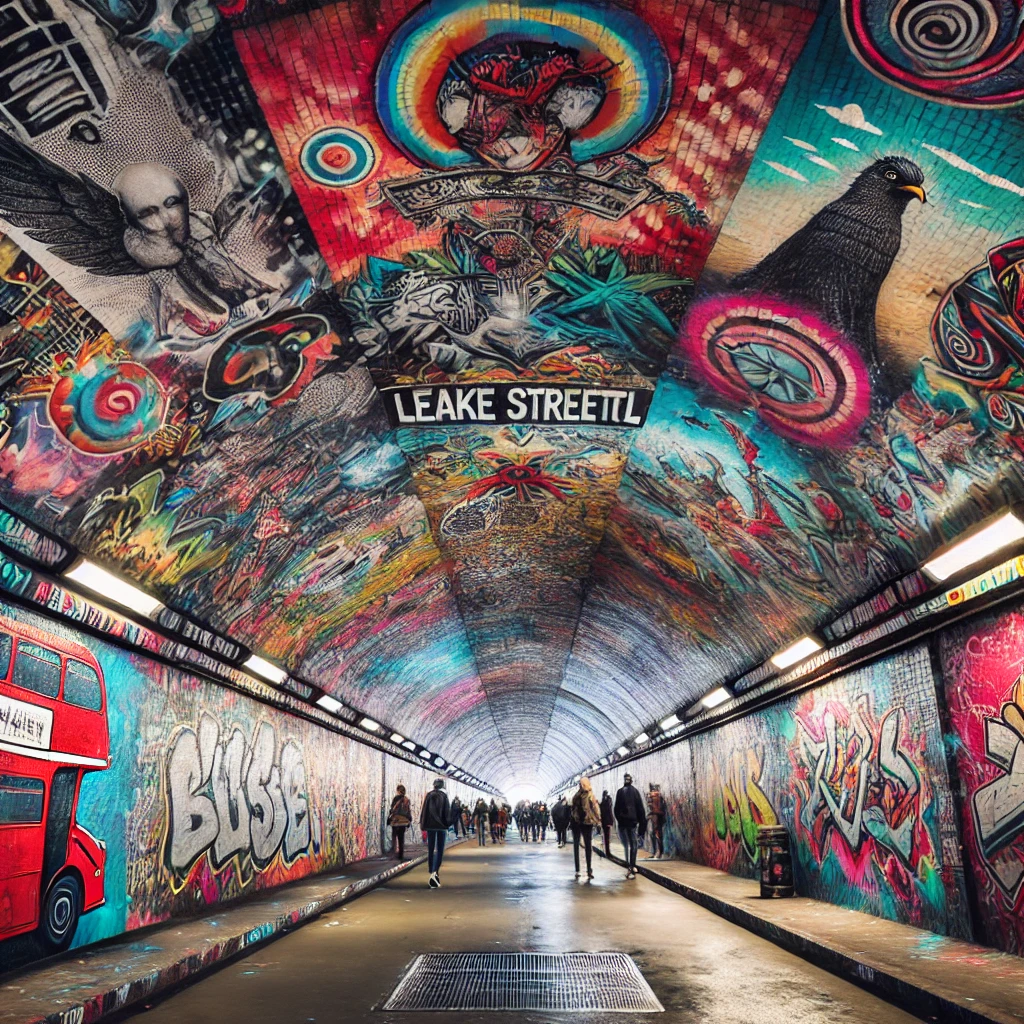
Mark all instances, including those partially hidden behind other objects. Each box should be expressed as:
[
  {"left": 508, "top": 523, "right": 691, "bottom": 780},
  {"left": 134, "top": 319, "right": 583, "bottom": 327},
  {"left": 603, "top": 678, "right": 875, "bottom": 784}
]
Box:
[{"left": 0, "top": 0, "right": 1024, "bottom": 785}]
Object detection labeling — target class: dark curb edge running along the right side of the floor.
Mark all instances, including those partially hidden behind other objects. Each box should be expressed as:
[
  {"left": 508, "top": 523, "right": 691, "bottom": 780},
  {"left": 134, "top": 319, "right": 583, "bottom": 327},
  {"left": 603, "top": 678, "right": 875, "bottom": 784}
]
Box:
[{"left": 594, "top": 844, "right": 1007, "bottom": 1024}]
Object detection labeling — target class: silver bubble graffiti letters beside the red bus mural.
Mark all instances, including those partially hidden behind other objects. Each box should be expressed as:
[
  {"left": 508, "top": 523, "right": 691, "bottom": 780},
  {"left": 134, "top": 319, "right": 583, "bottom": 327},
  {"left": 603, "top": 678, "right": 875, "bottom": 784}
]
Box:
[{"left": 165, "top": 715, "right": 312, "bottom": 879}]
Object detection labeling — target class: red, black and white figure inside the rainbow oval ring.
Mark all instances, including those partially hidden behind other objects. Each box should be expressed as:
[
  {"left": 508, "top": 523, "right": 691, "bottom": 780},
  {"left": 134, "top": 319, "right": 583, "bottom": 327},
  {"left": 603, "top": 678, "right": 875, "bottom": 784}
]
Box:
[{"left": 437, "top": 43, "right": 605, "bottom": 171}]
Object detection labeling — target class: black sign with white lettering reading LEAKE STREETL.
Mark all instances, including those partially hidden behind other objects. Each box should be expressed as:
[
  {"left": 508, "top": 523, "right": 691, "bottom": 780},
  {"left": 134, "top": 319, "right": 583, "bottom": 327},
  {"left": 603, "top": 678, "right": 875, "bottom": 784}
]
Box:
[{"left": 381, "top": 384, "right": 653, "bottom": 429}]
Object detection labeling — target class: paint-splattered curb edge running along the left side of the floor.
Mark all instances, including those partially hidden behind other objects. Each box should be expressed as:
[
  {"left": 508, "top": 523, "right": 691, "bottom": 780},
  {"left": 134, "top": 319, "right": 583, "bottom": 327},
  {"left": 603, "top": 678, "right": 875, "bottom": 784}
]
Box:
[{"left": 18, "top": 843, "right": 436, "bottom": 1024}]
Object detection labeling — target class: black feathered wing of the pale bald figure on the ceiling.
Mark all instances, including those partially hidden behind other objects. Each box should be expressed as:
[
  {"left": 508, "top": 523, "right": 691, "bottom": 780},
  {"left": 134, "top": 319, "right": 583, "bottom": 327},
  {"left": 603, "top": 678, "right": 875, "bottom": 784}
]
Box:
[{"left": 0, "top": 131, "right": 146, "bottom": 278}]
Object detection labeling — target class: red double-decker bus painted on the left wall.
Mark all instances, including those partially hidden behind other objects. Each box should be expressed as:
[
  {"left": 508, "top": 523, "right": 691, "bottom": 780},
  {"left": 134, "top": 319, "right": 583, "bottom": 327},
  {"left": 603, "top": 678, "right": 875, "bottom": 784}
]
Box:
[{"left": 0, "top": 615, "right": 111, "bottom": 950}]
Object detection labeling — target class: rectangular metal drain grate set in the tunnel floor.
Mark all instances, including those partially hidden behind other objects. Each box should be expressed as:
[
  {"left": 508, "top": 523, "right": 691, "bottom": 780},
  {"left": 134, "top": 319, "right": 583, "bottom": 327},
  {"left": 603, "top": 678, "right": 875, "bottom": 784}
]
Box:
[{"left": 382, "top": 953, "right": 665, "bottom": 1013}]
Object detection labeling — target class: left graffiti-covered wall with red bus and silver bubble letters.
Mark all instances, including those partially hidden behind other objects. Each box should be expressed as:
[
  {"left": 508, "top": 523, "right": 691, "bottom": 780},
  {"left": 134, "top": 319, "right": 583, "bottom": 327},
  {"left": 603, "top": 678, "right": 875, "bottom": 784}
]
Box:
[{"left": 0, "top": 604, "right": 479, "bottom": 961}]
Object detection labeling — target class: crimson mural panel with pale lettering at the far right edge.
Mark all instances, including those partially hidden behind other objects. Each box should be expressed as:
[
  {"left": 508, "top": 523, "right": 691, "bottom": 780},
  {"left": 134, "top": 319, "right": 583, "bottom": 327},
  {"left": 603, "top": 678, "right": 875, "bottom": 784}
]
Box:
[{"left": 941, "top": 609, "right": 1024, "bottom": 955}]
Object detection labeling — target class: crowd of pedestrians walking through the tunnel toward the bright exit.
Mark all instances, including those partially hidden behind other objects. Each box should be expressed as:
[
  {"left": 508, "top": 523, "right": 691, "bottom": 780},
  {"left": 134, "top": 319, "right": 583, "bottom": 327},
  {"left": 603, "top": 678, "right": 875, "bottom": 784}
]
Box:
[{"left": 387, "top": 774, "right": 666, "bottom": 889}]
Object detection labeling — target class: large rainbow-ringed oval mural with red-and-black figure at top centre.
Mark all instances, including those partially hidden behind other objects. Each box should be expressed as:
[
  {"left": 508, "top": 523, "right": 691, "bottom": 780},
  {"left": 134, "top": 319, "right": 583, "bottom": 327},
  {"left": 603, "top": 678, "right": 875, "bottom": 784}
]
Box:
[{"left": 375, "top": 0, "right": 671, "bottom": 170}]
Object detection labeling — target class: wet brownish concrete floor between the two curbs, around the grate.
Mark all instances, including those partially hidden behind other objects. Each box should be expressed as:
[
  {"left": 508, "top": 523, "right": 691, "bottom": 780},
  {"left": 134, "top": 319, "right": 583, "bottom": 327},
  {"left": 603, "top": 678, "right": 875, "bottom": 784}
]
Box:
[{"left": 117, "top": 836, "right": 918, "bottom": 1024}]
